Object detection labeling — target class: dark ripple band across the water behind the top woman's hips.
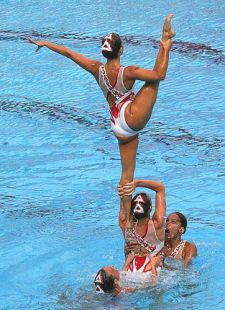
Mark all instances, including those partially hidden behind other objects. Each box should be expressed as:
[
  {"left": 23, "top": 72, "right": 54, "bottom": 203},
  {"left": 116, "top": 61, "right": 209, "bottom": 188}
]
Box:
[{"left": 0, "top": 96, "right": 225, "bottom": 164}]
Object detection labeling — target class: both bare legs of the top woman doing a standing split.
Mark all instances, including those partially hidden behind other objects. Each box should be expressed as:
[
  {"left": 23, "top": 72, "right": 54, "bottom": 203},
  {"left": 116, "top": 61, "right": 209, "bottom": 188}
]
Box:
[{"left": 118, "top": 14, "right": 174, "bottom": 227}]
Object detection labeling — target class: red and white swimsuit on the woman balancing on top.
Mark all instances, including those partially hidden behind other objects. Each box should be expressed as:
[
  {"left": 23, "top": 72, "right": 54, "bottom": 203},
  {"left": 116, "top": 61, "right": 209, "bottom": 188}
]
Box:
[{"left": 99, "top": 65, "right": 138, "bottom": 137}]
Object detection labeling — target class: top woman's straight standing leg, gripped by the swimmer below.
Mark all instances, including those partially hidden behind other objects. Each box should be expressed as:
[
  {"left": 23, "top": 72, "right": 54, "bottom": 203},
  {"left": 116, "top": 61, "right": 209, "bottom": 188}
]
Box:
[{"left": 119, "top": 135, "right": 138, "bottom": 227}]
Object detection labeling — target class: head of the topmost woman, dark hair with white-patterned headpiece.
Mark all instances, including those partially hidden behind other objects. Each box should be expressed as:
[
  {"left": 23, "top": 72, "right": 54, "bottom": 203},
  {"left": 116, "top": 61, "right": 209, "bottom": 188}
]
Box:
[{"left": 102, "top": 33, "right": 123, "bottom": 59}]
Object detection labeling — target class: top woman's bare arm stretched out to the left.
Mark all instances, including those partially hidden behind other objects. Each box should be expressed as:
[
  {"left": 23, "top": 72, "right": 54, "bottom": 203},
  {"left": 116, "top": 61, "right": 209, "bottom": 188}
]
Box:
[{"left": 27, "top": 38, "right": 101, "bottom": 77}]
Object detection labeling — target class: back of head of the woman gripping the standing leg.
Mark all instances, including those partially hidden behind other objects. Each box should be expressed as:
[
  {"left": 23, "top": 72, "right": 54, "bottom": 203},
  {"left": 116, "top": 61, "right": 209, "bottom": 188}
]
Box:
[{"left": 131, "top": 193, "right": 152, "bottom": 220}]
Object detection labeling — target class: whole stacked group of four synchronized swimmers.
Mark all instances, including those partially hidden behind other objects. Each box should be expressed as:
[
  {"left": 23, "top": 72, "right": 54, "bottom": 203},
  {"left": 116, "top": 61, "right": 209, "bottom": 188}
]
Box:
[{"left": 28, "top": 14, "right": 197, "bottom": 294}]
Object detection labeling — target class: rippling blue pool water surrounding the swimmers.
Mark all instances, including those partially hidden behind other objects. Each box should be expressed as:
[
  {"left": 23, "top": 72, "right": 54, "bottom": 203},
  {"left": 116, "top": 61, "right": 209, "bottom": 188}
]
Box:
[{"left": 0, "top": 0, "right": 225, "bottom": 310}]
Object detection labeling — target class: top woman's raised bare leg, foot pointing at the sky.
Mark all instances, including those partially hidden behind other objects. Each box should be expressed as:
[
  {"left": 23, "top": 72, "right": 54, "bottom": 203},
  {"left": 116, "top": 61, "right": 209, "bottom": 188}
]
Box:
[{"left": 125, "top": 14, "right": 175, "bottom": 130}]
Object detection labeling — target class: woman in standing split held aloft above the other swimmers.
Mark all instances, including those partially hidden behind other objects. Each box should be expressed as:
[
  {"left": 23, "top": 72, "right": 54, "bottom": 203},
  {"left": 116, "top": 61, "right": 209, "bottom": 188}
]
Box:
[{"left": 28, "top": 14, "right": 175, "bottom": 227}]
